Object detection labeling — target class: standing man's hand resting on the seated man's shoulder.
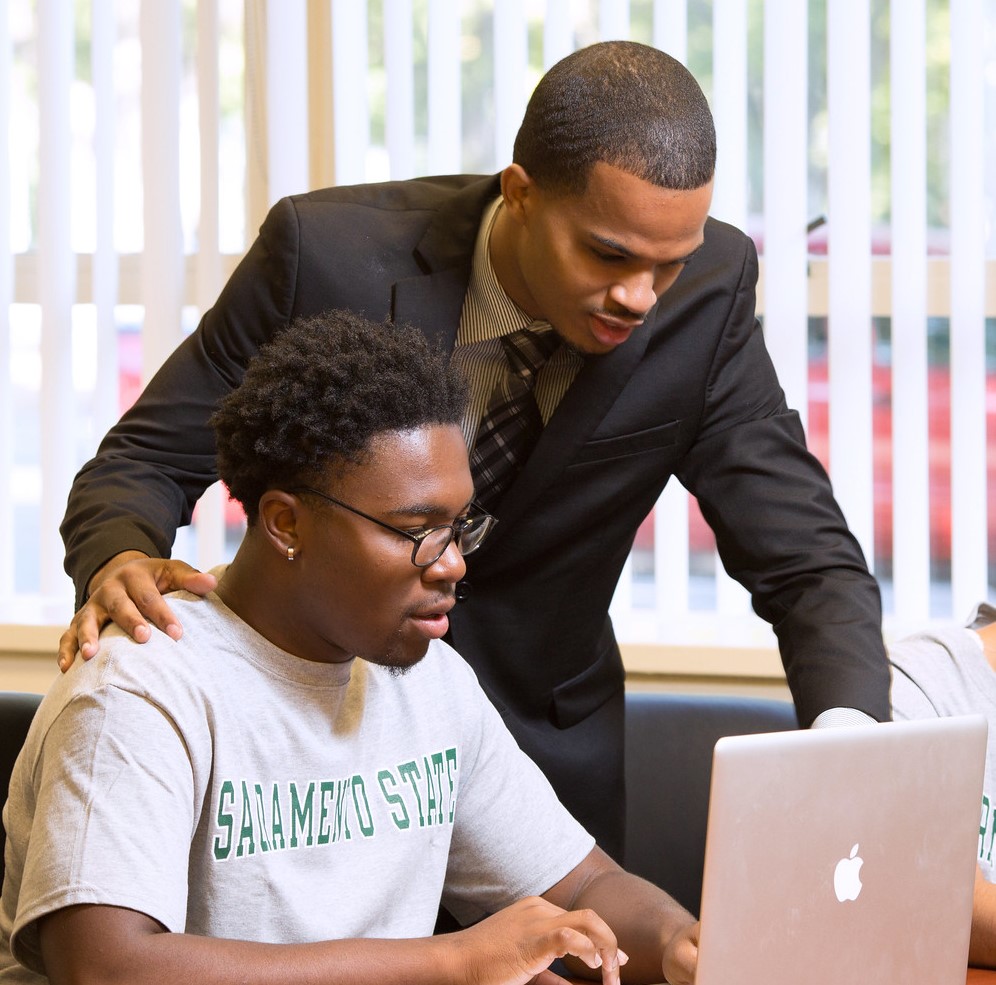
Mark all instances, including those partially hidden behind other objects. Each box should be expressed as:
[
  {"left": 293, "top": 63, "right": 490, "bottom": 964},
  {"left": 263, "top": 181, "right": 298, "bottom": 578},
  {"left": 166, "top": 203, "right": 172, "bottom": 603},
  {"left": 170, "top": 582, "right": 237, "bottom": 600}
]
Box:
[{"left": 59, "top": 551, "right": 217, "bottom": 673}]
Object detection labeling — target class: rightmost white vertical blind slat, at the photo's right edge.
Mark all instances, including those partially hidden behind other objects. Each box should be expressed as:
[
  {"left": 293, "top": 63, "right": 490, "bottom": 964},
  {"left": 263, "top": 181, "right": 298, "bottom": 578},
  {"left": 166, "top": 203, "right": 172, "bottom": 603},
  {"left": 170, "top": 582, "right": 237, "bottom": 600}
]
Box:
[{"left": 950, "top": 0, "right": 987, "bottom": 618}]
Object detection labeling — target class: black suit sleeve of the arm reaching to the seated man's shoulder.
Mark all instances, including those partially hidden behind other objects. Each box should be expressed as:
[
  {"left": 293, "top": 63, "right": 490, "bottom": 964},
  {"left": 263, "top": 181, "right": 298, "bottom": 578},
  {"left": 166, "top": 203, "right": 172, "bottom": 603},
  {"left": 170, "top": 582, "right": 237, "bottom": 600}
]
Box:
[{"left": 60, "top": 199, "right": 299, "bottom": 607}]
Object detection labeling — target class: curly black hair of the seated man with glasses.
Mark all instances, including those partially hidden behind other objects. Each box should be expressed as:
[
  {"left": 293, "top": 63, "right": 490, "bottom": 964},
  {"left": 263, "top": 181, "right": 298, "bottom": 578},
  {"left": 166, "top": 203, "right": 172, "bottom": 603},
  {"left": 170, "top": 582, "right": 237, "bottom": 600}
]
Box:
[{"left": 211, "top": 311, "right": 467, "bottom": 524}]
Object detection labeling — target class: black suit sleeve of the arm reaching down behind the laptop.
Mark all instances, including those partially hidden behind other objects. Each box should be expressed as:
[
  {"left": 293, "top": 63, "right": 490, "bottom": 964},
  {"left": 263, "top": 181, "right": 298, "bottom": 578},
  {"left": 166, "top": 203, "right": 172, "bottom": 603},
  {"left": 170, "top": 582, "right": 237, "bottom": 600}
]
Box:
[{"left": 677, "top": 232, "right": 890, "bottom": 726}]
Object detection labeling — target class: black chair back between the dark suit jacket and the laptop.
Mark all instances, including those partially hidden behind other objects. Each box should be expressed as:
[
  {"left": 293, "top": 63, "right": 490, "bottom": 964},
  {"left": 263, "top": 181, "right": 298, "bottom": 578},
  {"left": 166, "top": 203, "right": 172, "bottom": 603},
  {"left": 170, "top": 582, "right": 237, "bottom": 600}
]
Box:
[{"left": 625, "top": 691, "right": 799, "bottom": 914}]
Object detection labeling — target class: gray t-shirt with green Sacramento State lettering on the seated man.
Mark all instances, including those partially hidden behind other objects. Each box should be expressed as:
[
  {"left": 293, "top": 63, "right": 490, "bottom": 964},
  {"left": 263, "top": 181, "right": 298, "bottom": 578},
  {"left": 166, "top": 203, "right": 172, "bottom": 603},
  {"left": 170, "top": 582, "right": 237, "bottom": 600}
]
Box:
[{"left": 0, "top": 593, "right": 593, "bottom": 983}]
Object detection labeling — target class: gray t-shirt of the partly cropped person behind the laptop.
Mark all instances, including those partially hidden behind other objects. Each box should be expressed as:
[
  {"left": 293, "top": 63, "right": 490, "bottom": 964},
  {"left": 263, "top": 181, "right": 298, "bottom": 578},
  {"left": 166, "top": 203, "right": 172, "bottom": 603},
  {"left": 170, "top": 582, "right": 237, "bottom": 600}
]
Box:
[{"left": 889, "top": 606, "right": 996, "bottom": 882}]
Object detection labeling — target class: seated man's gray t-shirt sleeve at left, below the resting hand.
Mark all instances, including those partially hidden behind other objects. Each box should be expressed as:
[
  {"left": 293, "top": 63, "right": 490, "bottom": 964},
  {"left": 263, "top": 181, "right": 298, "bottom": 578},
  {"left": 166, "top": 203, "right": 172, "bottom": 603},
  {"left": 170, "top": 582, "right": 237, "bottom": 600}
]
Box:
[{"left": 11, "top": 686, "right": 194, "bottom": 971}]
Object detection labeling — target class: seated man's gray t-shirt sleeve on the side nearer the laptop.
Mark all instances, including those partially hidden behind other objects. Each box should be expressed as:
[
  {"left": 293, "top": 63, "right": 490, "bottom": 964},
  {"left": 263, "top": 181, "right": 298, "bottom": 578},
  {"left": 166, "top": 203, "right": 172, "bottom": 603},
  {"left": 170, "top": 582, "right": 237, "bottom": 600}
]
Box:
[{"left": 443, "top": 656, "right": 595, "bottom": 919}]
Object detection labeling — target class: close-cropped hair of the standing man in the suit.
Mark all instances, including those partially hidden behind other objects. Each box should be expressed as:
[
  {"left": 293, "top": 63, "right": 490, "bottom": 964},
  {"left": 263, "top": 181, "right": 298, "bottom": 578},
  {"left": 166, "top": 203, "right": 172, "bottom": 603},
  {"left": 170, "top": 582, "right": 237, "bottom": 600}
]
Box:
[{"left": 512, "top": 41, "right": 716, "bottom": 195}]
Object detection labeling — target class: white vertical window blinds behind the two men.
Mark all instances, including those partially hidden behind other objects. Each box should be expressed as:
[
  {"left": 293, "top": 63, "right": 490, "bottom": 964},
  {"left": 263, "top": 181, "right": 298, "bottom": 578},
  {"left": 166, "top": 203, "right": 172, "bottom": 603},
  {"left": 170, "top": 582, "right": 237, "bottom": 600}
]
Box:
[{"left": 0, "top": 0, "right": 996, "bottom": 645}]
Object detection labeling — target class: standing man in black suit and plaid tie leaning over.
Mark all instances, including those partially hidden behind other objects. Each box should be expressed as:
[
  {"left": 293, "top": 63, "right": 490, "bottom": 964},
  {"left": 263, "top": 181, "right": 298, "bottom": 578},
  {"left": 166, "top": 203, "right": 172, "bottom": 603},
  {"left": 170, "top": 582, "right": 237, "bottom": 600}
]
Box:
[{"left": 60, "top": 42, "right": 889, "bottom": 856}]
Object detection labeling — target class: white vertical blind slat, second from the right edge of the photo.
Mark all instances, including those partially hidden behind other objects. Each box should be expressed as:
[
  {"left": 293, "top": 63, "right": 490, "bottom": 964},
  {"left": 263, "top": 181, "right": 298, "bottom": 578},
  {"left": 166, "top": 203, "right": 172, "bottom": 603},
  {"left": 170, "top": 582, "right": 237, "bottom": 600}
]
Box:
[{"left": 890, "top": 0, "right": 930, "bottom": 626}]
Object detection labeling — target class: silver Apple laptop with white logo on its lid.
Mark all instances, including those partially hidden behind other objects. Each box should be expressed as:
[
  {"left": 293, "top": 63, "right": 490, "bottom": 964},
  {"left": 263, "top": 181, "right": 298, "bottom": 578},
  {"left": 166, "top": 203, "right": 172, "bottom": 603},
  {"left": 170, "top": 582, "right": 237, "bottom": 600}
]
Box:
[{"left": 695, "top": 716, "right": 987, "bottom": 985}]
